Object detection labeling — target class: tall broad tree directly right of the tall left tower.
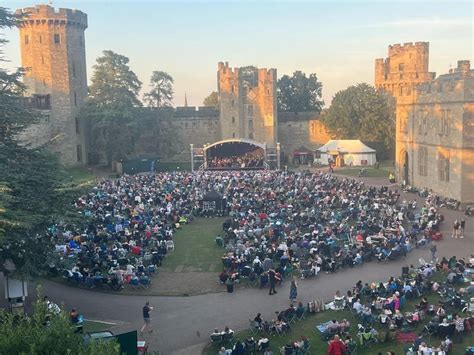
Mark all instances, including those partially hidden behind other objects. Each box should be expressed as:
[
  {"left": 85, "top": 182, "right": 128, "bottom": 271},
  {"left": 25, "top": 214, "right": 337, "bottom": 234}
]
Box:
[{"left": 80, "top": 51, "right": 142, "bottom": 165}]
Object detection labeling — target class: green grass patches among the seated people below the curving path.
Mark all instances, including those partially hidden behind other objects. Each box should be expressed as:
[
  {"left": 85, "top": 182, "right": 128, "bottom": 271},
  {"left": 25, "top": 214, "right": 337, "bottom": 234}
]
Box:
[{"left": 203, "top": 277, "right": 474, "bottom": 355}]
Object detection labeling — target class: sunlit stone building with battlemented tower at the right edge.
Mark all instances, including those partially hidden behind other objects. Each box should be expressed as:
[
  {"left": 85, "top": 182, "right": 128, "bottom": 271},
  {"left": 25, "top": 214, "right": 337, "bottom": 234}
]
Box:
[{"left": 375, "top": 43, "right": 474, "bottom": 203}]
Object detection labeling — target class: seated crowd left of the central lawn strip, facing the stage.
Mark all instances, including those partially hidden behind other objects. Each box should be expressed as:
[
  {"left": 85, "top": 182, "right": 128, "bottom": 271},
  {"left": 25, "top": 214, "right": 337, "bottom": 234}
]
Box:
[{"left": 48, "top": 173, "right": 202, "bottom": 290}]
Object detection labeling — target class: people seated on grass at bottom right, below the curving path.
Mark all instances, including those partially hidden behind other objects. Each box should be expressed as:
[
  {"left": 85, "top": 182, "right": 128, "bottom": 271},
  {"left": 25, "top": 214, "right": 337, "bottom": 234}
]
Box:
[{"left": 212, "top": 255, "right": 474, "bottom": 355}]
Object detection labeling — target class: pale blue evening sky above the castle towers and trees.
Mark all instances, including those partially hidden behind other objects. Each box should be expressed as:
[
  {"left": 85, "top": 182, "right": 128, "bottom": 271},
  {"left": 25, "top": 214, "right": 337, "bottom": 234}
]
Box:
[{"left": 0, "top": 0, "right": 474, "bottom": 106}]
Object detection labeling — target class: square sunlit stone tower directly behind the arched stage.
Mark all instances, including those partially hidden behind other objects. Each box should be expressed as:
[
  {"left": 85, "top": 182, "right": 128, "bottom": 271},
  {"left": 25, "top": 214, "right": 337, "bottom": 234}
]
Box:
[{"left": 217, "top": 62, "right": 277, "bottom": 147}]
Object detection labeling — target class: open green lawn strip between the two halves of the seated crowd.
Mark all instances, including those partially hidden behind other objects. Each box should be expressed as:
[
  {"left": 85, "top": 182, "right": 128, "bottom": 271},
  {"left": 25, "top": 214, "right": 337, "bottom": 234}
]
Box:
[{"left": 162, "top": 218, "right": 225, "bottom": 273}]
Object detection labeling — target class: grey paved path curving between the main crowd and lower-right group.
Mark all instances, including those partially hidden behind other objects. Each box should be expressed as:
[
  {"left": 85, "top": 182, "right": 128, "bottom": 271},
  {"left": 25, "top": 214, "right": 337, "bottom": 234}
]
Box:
[{"left": 0, "top": 191, "right": 474, "bottom": 354}]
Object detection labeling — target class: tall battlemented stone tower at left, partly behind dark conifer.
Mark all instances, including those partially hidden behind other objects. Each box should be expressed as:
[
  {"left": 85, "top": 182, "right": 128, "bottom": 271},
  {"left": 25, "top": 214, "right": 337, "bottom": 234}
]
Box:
[{"left": 17, "top": 5, "right": 87, "bottom": 165}]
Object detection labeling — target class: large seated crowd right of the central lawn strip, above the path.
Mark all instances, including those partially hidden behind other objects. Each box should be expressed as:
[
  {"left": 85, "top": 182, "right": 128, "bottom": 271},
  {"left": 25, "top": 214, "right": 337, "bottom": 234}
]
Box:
[{"left": 216, "top": 172, "right": 443, "bottom": 293}]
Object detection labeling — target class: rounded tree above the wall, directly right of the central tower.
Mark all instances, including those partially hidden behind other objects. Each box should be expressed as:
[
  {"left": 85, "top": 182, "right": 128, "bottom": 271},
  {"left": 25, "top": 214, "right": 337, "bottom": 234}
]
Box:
[{"left": 277, "top": 70, "right": 324, "bottom": 113}]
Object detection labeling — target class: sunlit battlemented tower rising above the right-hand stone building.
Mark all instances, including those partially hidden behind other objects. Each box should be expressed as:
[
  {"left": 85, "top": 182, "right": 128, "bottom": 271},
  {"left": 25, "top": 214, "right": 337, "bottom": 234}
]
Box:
[{"left": 375, "top": 42, "right": 434, "bottom": 98}]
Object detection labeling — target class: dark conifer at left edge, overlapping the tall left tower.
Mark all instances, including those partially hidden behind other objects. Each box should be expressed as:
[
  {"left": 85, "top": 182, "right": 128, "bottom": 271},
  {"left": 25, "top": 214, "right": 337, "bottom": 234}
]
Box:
[{"left": 0, "top": 8, "right": 85, "bottom": 278}]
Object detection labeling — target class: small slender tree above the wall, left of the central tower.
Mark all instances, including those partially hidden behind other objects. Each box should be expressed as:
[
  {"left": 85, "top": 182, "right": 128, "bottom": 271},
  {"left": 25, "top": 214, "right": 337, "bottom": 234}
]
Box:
[{"left": 144, "top": 71, "right": 174, "bottom": 107}]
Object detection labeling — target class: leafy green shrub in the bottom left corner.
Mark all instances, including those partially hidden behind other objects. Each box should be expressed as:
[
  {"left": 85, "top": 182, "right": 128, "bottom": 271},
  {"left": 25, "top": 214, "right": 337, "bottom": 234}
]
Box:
[{"left": 0, "top": 290, "right": 120, "bottom": 355}]
